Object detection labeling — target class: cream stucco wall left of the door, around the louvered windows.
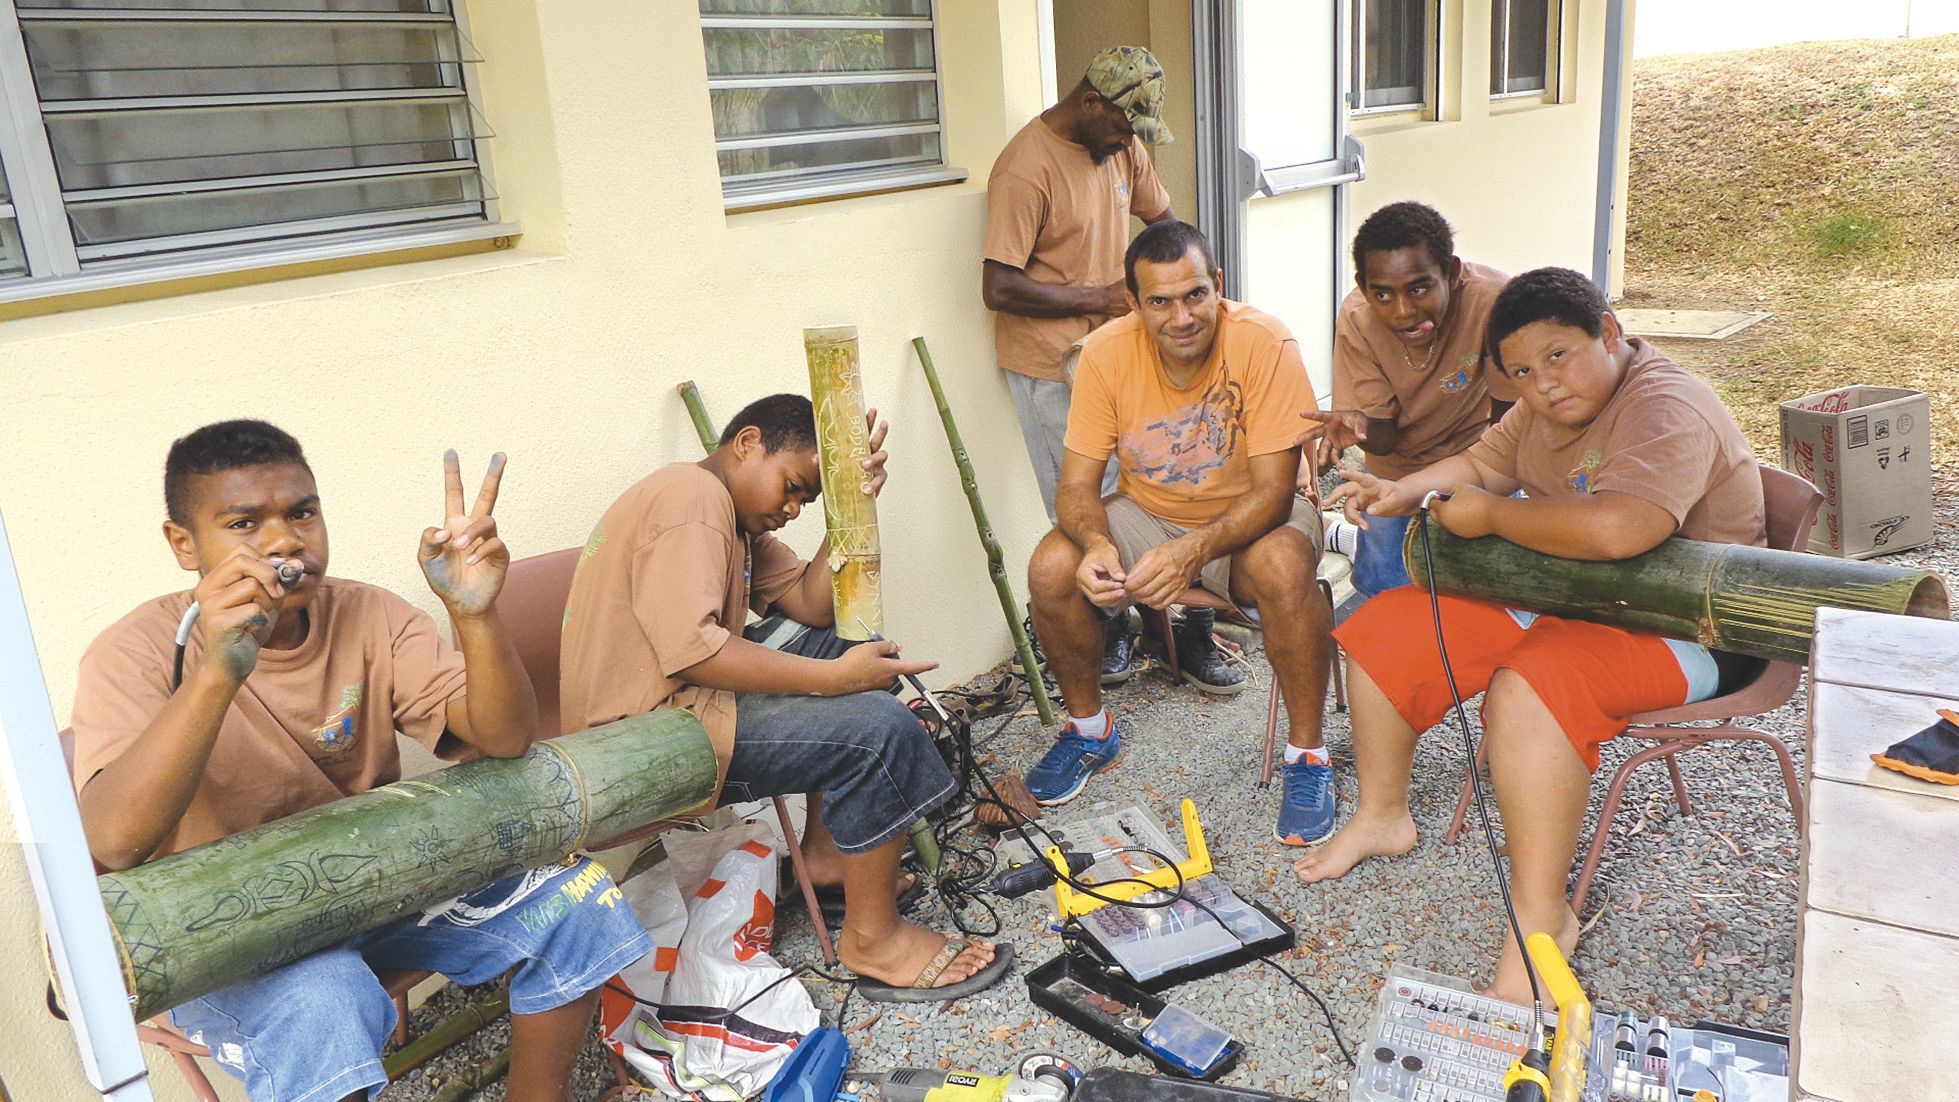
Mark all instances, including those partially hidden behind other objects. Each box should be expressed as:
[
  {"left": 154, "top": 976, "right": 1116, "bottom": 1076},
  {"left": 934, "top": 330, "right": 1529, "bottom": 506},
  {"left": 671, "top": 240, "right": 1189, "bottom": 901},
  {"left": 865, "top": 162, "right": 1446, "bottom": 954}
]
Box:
[{"left": 0, "top": 0, "right": 1046, "bottom": 1100}]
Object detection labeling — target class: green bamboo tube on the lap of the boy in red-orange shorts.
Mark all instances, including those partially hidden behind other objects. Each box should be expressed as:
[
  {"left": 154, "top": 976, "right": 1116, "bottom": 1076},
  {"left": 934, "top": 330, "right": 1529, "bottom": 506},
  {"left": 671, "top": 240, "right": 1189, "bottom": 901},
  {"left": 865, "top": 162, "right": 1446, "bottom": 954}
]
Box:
[{"left": 1401, "top": 519, "right": 1951, "bottom": 666}]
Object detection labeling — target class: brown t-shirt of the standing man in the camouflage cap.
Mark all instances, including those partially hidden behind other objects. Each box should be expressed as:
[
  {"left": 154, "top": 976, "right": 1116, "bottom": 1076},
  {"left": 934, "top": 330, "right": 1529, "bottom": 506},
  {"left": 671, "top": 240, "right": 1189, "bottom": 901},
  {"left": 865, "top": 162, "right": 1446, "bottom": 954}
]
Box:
[{"left": 985, "top": 115, "right": 1170, "bottom": 380}]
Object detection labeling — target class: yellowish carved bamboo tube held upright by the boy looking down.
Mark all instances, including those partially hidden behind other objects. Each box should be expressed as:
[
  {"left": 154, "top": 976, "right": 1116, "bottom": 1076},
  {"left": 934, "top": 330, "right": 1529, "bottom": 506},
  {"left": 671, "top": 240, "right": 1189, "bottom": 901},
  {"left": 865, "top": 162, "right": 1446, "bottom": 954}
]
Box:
[{"left": 803, "top": 325, "right": 884, "bottom": 642}]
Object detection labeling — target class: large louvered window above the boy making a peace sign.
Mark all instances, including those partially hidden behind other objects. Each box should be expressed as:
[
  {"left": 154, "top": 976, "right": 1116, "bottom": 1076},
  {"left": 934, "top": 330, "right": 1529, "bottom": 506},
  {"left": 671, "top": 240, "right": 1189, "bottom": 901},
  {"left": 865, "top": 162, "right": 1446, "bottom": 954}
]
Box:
[{"left": 0, "top": 0, "right": 496, "bottom": 297}]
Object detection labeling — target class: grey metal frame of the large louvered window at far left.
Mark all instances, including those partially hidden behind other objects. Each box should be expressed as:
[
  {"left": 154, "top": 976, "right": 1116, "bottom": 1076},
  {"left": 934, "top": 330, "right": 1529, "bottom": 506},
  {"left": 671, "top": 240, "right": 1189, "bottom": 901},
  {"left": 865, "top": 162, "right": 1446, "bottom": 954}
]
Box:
[{"left": 0, "top": 0, "right": 523, "bottom": 303}]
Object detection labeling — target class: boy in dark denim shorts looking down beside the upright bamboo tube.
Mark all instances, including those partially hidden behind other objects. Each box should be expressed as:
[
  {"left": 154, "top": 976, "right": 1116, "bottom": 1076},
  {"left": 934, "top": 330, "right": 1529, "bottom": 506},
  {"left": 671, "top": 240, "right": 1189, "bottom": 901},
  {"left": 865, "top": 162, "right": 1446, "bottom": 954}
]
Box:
[{"left": 562, "top": 393, "right": 1011, "bottom": 1002}]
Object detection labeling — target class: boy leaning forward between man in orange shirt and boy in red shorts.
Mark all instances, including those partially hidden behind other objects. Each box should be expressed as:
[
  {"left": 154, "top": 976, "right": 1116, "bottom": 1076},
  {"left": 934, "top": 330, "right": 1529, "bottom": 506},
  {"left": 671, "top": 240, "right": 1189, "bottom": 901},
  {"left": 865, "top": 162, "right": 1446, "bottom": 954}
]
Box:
[{"left": 1301, "top": 202, "right": 1516, "bottom": 597}]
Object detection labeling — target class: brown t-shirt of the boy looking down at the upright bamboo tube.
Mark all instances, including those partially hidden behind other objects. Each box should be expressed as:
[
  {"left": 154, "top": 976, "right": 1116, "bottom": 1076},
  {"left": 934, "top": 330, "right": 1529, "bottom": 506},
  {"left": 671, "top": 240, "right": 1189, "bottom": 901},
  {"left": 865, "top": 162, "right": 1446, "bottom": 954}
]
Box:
[{"left": 558, "top": 462, "right": 809, "bottom": 806}]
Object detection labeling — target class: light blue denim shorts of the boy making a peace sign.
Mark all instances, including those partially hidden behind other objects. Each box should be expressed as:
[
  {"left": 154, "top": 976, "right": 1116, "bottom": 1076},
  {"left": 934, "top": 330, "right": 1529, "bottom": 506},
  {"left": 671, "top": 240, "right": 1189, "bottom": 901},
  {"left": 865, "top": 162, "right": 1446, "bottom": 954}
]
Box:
[{"left": 170, "top": 857, "right": 652, "bottom": 1102}]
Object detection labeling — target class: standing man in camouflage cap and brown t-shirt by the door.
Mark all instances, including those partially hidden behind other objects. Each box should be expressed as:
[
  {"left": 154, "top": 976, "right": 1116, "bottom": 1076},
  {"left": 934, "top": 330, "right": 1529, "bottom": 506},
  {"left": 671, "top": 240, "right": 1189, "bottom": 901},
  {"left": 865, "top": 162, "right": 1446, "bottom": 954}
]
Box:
[{"left": 980, "top": 45, "right": 1175, "bottom": 685}]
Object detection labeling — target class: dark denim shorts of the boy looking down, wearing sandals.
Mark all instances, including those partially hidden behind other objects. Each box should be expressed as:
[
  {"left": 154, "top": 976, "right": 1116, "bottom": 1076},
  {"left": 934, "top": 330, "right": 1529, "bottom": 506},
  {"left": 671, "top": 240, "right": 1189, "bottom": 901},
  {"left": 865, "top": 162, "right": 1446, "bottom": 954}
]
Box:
[{"left": 721, "top": 617, "right": 958, "bottom": 853}]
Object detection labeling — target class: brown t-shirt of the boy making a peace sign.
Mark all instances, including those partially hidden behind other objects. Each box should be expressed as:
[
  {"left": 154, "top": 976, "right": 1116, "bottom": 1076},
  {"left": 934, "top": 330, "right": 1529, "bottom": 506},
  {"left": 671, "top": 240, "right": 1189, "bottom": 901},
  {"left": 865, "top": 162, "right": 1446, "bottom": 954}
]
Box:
[{"left": 72, "top": 577, "right": 464, "bottom": 857}]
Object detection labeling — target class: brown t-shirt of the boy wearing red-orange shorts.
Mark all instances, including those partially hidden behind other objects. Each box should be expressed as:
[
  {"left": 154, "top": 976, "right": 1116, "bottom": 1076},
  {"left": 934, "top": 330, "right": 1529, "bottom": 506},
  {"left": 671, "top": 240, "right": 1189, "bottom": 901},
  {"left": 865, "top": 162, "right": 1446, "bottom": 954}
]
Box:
[{"left": 1469, "top": 337, "right": 1767, "bottom": 546}]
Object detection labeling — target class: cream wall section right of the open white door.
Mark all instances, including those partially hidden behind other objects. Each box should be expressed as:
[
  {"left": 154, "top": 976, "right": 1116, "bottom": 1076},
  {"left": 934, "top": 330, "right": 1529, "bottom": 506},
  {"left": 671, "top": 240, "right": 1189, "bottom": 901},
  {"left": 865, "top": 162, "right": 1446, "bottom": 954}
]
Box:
[{"left": 1350, "top": 0, "right": 1630, "bottom": 291}]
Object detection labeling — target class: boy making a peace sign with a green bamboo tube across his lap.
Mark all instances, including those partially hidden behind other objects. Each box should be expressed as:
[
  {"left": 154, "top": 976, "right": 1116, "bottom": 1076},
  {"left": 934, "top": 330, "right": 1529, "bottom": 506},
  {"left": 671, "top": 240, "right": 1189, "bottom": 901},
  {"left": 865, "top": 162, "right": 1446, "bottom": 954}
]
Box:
[{"left": 74, "top": 421, "right": 652, "bottom": 1102}]
